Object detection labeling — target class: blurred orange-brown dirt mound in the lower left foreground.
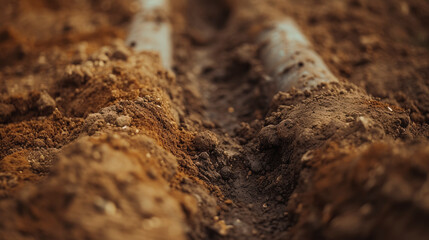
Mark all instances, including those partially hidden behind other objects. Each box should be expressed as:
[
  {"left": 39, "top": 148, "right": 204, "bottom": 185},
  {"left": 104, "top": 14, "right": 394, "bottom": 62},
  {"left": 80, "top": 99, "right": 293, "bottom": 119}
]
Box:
[{"left": 0, "top": 135, "right": 190, "bottom": 239}]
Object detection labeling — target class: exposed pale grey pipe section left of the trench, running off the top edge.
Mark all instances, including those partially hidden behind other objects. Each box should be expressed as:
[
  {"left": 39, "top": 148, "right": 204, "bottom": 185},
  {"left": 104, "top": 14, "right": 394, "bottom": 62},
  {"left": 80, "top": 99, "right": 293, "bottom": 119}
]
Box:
[{"left": 126, "top": 0, "right": 173, "bottom": 69}]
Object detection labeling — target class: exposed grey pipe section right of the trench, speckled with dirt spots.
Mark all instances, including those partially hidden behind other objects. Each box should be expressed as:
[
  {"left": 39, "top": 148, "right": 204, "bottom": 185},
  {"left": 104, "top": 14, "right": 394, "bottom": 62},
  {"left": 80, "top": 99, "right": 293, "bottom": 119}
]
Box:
[{"left": 259, "top": 18, "right": 338, "bottom": 91}]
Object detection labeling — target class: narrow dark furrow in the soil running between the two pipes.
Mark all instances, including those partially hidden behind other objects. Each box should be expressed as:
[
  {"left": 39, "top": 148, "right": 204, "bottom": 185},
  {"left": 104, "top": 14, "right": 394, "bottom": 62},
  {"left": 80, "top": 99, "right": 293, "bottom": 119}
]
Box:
[{"left": 176, "top": 0, "right": 293, "bottom": 239}]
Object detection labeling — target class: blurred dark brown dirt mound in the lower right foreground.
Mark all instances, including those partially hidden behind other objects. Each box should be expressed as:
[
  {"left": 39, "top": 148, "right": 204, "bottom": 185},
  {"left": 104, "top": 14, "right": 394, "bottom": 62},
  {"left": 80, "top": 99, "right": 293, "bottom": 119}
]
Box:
[{"left": 289, "top": 142, "right": 429, "bottom": 239}]
